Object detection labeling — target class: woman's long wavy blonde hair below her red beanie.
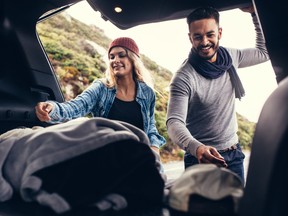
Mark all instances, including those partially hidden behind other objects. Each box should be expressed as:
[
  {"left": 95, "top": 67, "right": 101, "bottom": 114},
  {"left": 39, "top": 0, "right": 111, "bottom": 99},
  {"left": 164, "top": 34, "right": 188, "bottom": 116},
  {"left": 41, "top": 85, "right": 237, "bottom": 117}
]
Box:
[{"left": 103, "top": 48, "right": 153, "bottom": 88}]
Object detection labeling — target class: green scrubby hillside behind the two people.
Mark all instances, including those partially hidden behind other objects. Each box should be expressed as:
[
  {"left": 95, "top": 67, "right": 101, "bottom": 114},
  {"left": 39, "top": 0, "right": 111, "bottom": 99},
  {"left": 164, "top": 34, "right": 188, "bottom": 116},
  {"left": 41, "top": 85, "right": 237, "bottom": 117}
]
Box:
[{"left": 37, "top": 13, "right": 255, "bottom": 161}]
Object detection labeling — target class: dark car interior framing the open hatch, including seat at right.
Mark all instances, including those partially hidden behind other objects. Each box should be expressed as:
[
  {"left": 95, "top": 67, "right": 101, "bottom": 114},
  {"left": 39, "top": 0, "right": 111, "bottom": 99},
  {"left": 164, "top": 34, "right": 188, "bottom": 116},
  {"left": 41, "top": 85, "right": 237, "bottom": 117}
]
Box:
[{"left": 0, "top": 0, "right": 288, "bottom": 216}]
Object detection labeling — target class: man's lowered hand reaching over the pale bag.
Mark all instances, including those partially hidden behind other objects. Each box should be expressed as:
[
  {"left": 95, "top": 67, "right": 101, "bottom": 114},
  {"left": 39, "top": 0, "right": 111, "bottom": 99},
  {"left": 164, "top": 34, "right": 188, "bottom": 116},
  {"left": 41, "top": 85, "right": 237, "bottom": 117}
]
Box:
[{"left": 196, "top": 145, "right": 227, "bottom": 167}]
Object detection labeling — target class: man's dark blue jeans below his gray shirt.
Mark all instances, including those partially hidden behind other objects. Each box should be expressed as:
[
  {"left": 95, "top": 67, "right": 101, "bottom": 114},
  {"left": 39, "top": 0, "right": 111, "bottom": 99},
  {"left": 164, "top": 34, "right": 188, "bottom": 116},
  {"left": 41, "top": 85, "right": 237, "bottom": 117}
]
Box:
[{"left": 184, "top": 143, "right": 245, "bottom": 185}]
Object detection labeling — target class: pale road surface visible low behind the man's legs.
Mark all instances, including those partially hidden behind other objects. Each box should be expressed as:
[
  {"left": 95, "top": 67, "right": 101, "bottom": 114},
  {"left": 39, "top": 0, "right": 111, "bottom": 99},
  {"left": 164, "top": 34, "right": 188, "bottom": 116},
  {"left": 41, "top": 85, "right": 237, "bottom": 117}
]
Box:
[{"left": 163, "top": 151, "right": 250, "bottom": 179}]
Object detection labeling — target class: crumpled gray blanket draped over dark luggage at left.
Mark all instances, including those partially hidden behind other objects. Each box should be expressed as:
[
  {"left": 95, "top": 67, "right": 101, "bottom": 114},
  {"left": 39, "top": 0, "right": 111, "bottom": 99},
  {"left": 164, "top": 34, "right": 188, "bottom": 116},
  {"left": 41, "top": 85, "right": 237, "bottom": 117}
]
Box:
[{"left": 0, "top": 118, "right": 165, "bottom": 213}]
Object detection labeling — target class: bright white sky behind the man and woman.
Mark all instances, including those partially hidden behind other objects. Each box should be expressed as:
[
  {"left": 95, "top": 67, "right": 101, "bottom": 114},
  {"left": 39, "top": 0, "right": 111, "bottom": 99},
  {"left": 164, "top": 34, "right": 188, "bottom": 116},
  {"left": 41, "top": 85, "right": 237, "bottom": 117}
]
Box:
[{"left": 67, "top": 1, "right": 277, "bottom": 122}]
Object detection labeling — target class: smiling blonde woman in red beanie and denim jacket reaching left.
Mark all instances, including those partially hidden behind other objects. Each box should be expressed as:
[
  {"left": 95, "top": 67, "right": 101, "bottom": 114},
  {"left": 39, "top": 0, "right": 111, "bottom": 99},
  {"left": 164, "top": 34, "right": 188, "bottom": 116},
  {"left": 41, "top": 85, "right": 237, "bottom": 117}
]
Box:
[{"left": 35, "top": 37, "right": 166, "bottom": 153}]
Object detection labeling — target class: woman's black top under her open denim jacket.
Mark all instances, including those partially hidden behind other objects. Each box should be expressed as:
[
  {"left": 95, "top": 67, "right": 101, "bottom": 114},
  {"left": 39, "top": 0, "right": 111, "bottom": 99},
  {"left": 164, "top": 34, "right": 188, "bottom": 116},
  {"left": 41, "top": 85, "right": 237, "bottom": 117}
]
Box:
[{"left": 108, "top": 98, "right": 144, "bottom": 130}]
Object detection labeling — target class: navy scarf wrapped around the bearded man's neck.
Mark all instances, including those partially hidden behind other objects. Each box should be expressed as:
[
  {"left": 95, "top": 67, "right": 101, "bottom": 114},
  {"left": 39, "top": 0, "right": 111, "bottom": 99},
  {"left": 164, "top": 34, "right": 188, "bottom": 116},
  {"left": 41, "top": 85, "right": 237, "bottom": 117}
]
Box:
[{"left": 188, "top": 46, "right": 245, "bottom": 100}]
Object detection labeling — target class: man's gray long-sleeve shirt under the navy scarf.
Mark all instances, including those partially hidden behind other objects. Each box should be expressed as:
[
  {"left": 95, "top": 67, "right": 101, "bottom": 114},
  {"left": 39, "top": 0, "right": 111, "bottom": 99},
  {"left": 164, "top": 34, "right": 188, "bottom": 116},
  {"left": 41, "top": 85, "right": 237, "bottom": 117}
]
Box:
[{"left": 166, "top": 17, "right": 269, "bottom": 156}]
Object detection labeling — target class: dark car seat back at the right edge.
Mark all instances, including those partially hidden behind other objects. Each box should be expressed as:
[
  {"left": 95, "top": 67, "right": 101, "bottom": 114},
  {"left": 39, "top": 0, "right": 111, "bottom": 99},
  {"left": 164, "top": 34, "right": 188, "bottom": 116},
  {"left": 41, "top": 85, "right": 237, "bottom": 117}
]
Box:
[{"left": 239, "top": 78, "right": 288, "bottom": 216}]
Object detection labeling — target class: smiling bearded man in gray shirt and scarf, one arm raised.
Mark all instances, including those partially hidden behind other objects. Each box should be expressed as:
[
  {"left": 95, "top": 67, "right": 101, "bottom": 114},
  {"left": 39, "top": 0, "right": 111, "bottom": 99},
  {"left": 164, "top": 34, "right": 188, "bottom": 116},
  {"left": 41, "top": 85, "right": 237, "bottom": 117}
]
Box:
[{"left": 166, "top": 7, "right": 269, "bottom": 184}]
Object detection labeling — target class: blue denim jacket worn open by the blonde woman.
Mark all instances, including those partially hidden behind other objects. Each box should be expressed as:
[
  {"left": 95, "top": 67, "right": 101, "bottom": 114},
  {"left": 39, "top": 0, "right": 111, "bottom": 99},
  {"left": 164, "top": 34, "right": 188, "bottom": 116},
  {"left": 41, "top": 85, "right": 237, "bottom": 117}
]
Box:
[{"left": 47, "top": 80, "right": 166, "bottom": 148}]
